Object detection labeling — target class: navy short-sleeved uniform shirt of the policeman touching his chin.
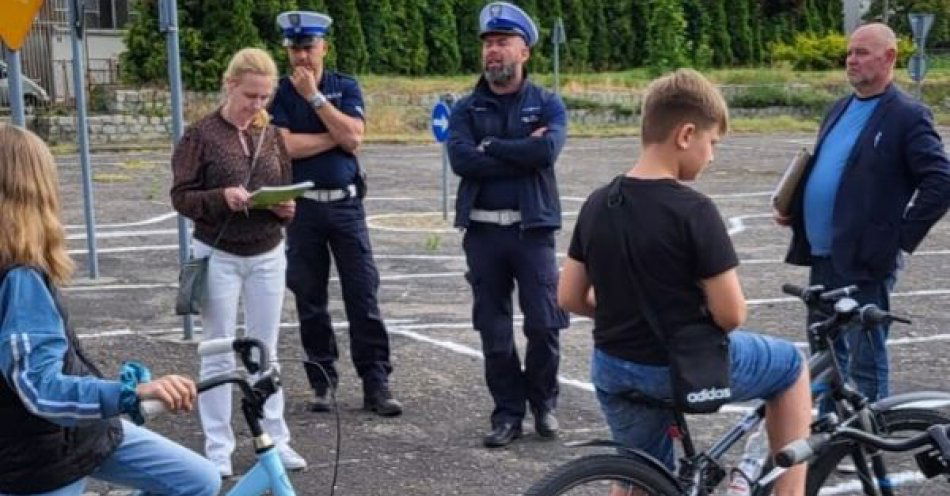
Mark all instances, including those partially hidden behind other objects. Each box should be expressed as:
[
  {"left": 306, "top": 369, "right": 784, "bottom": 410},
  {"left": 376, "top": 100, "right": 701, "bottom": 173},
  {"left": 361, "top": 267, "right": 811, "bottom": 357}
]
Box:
[{"left": 270, "top": 70, "right": 364, "bottom": 189}]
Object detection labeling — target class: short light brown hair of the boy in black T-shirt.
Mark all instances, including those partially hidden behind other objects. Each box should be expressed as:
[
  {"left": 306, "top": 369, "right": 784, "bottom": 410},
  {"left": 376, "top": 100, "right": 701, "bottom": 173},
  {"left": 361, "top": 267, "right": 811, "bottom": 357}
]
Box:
[{"left": 640, "top": 69, "right": 729, "bottom": 145}]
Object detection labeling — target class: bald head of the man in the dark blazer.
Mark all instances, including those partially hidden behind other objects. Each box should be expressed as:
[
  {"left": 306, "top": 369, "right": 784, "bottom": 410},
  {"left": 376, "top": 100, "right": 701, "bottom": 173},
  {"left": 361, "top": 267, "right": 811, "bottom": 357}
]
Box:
[{"left": 847, "top": 23, "right": 897, "bottom": 97}]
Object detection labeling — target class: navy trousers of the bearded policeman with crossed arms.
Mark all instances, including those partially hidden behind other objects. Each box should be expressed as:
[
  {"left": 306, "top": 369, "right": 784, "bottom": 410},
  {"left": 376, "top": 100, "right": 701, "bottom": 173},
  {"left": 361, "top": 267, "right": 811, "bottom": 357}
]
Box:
[{"left": 463, "top": 222, "right": 568, "bottom": 426}]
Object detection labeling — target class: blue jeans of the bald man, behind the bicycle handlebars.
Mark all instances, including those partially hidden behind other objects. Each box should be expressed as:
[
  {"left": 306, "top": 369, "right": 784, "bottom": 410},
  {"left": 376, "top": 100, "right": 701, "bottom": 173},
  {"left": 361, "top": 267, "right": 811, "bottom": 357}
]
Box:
[{"left": 808, "top": 257, "right": 896, "bottom": 413}]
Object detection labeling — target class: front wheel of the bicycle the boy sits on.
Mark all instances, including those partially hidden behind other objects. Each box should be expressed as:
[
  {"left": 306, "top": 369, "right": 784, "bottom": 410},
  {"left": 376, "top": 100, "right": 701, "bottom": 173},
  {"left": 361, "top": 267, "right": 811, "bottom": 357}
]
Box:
[{"left": 805, "top": 408, "right": 950, "bottom": 496}]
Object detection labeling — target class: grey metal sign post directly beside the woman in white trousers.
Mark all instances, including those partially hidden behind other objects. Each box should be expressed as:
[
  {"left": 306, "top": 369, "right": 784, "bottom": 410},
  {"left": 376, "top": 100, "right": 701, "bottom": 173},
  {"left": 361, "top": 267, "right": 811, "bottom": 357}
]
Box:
[{"left": 158, "top": 0, "right": 194, "bottom": 341}]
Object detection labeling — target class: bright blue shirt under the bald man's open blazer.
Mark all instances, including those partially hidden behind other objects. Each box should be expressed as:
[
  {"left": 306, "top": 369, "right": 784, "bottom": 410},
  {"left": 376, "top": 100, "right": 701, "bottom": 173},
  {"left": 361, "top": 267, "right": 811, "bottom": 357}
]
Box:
[{"left": 804, "top": 96, "right": 881, "bottom": 256}]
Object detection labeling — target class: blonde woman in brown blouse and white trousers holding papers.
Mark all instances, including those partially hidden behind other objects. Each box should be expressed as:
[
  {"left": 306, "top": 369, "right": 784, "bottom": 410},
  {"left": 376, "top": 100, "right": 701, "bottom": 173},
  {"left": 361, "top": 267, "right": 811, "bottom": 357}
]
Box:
[{"left": 171, "top": 48, "right": 307, "bottom": 477}]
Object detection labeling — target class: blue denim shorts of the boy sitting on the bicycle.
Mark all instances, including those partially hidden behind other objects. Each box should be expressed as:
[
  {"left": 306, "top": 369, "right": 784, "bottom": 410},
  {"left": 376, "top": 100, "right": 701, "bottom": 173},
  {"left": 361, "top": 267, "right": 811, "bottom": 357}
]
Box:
[{"left": 591, "top": 331, "right": 805, "bottom": 470}]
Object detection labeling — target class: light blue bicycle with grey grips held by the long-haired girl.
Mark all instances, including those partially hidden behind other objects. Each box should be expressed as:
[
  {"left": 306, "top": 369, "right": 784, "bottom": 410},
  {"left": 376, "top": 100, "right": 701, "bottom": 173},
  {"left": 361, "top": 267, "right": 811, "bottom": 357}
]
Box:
[{"left": 136, "top": 338, "right": 296, "bottom": 496}]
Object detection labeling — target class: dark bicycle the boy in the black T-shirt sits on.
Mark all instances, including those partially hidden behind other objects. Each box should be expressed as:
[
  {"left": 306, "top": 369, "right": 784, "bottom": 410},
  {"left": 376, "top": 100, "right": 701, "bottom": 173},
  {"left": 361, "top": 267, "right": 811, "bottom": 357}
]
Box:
[{"left": 525, "top": 285, "right": 950, "bottom": 496}]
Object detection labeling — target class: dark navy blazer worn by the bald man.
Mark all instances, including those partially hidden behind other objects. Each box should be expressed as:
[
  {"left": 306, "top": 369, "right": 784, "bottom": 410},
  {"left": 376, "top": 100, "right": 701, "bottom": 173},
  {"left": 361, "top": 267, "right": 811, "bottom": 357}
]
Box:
[{"left": 786, "top": 84, "right": 950, "bottom": 282}]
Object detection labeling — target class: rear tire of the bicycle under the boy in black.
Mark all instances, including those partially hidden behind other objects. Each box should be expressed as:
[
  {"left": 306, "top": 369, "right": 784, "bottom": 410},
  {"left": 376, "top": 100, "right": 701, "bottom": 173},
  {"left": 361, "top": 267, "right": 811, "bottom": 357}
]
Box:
[{"left": 524, "top": 454, "right": 681, "bottom": 496}]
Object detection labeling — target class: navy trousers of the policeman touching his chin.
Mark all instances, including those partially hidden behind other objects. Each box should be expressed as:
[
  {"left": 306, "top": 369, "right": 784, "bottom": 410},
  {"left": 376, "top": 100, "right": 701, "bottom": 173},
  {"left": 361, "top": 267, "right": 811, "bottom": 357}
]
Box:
[{"left": 287, "top": 198, "right": 392, "bottom": 393}]
